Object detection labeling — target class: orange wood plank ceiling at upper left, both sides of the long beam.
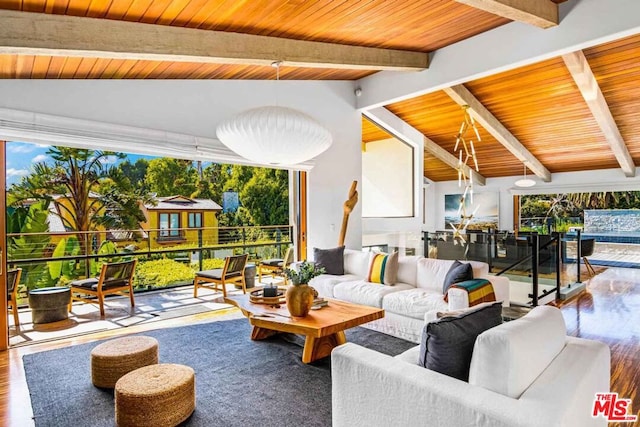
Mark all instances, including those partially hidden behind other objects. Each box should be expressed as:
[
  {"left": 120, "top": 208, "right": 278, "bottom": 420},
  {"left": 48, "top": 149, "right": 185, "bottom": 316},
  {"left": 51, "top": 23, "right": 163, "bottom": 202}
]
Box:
[{"left": 0, "top": 0, "right": 509, "bottom": 80}]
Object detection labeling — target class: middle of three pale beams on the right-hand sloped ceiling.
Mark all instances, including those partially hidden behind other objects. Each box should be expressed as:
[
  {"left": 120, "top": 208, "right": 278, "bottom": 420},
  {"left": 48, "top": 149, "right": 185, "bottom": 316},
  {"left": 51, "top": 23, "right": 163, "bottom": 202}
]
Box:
[{"left": 444, "top": 85, "right": 551, "bottom": 182}]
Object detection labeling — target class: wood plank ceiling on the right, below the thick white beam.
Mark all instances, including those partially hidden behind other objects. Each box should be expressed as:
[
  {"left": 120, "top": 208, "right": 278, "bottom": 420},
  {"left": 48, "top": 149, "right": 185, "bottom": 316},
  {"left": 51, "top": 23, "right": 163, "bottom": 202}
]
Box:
[{"left": 365, "top": 31, "right": 640, "bottom": 181}]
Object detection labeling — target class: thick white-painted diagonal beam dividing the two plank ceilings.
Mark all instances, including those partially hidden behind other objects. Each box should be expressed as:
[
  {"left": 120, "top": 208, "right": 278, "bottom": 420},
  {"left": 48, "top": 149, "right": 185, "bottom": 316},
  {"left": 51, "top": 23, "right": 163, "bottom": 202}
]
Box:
[{"left": 357, "top": 0, "right": 640, "bottom": 110}]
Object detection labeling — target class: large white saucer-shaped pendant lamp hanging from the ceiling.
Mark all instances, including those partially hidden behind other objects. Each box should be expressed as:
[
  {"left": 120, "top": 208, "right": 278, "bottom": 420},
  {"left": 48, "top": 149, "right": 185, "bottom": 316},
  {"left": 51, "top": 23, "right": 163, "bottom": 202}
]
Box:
[{"left": 216, "top": 62, "right": 332, "bottom": 165}]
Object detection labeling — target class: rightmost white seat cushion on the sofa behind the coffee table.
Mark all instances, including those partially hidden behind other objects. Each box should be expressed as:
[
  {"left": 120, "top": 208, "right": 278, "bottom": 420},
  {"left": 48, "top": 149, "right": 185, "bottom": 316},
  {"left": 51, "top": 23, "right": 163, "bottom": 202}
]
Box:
[{"left": 382, "top": 288, "right": 448, "bottom": 319}]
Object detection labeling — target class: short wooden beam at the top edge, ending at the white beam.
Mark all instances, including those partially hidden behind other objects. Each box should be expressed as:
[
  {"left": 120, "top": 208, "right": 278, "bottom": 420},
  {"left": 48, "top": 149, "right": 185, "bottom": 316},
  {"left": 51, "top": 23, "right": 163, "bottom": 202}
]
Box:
[{"left": 456, "top": 0, "right": 558, "bottom": 28}]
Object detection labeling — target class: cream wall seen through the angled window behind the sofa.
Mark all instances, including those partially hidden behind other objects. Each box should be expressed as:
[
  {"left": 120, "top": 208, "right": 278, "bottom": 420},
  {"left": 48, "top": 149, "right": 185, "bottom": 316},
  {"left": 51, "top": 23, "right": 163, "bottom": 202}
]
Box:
[{"left": 361, "top": 138, "right": 414, "bottom": 218}]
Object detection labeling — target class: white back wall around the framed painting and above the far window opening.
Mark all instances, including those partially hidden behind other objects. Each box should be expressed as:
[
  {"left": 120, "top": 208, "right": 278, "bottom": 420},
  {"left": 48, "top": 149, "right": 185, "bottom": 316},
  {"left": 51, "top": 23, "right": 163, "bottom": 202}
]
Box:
[{"left": 425, "top": 168, "right": 640, "bottom": 231}]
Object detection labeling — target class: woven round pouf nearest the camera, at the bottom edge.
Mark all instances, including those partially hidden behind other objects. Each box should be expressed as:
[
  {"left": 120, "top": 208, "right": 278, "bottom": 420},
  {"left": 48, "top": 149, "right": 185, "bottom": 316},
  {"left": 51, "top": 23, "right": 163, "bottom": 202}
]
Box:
[{"left": 115, "top": 363, "right": 196, "bottom": 427}]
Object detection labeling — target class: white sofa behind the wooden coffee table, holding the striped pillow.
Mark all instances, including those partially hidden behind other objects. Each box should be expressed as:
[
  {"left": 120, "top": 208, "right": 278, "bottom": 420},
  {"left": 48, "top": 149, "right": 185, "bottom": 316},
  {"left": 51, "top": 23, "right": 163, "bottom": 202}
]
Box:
[{"left": 309, "top": 249, "right": 509, "bottom": 343}]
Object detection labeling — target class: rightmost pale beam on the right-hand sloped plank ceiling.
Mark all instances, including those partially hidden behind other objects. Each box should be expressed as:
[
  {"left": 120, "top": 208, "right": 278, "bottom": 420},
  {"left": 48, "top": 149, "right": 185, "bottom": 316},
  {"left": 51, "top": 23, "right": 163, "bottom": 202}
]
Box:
[{"left": 562, "top": 50, "right": 636, "bottom": 177}]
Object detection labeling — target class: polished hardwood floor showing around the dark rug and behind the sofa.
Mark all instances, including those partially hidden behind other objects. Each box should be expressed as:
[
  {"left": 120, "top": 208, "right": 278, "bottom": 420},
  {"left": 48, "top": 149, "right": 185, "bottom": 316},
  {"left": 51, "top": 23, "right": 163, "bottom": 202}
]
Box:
[{"left": 0, "top": 268, "right": 640, "bottom": 427}]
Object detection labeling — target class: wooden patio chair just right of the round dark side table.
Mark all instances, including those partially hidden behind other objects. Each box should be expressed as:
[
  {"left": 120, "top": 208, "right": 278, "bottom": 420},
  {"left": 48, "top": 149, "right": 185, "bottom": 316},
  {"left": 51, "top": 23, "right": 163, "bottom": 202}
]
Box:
[{"left": 69, "top": 259, "right": 138, "bottom": 316}]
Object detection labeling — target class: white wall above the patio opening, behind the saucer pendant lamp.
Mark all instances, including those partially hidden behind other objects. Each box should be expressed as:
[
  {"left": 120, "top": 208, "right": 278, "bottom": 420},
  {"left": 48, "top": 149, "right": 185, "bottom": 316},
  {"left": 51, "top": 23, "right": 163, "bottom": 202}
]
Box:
[{"left": 0, "top": 80, "right": 362, "bottom": 254}]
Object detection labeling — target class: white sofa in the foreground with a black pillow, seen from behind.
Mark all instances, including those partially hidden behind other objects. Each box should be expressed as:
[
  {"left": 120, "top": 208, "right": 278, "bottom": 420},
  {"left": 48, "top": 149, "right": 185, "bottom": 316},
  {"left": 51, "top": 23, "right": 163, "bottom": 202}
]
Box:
[{"left": 331, "top": 306, "right": 610, "bottom": 427}]
